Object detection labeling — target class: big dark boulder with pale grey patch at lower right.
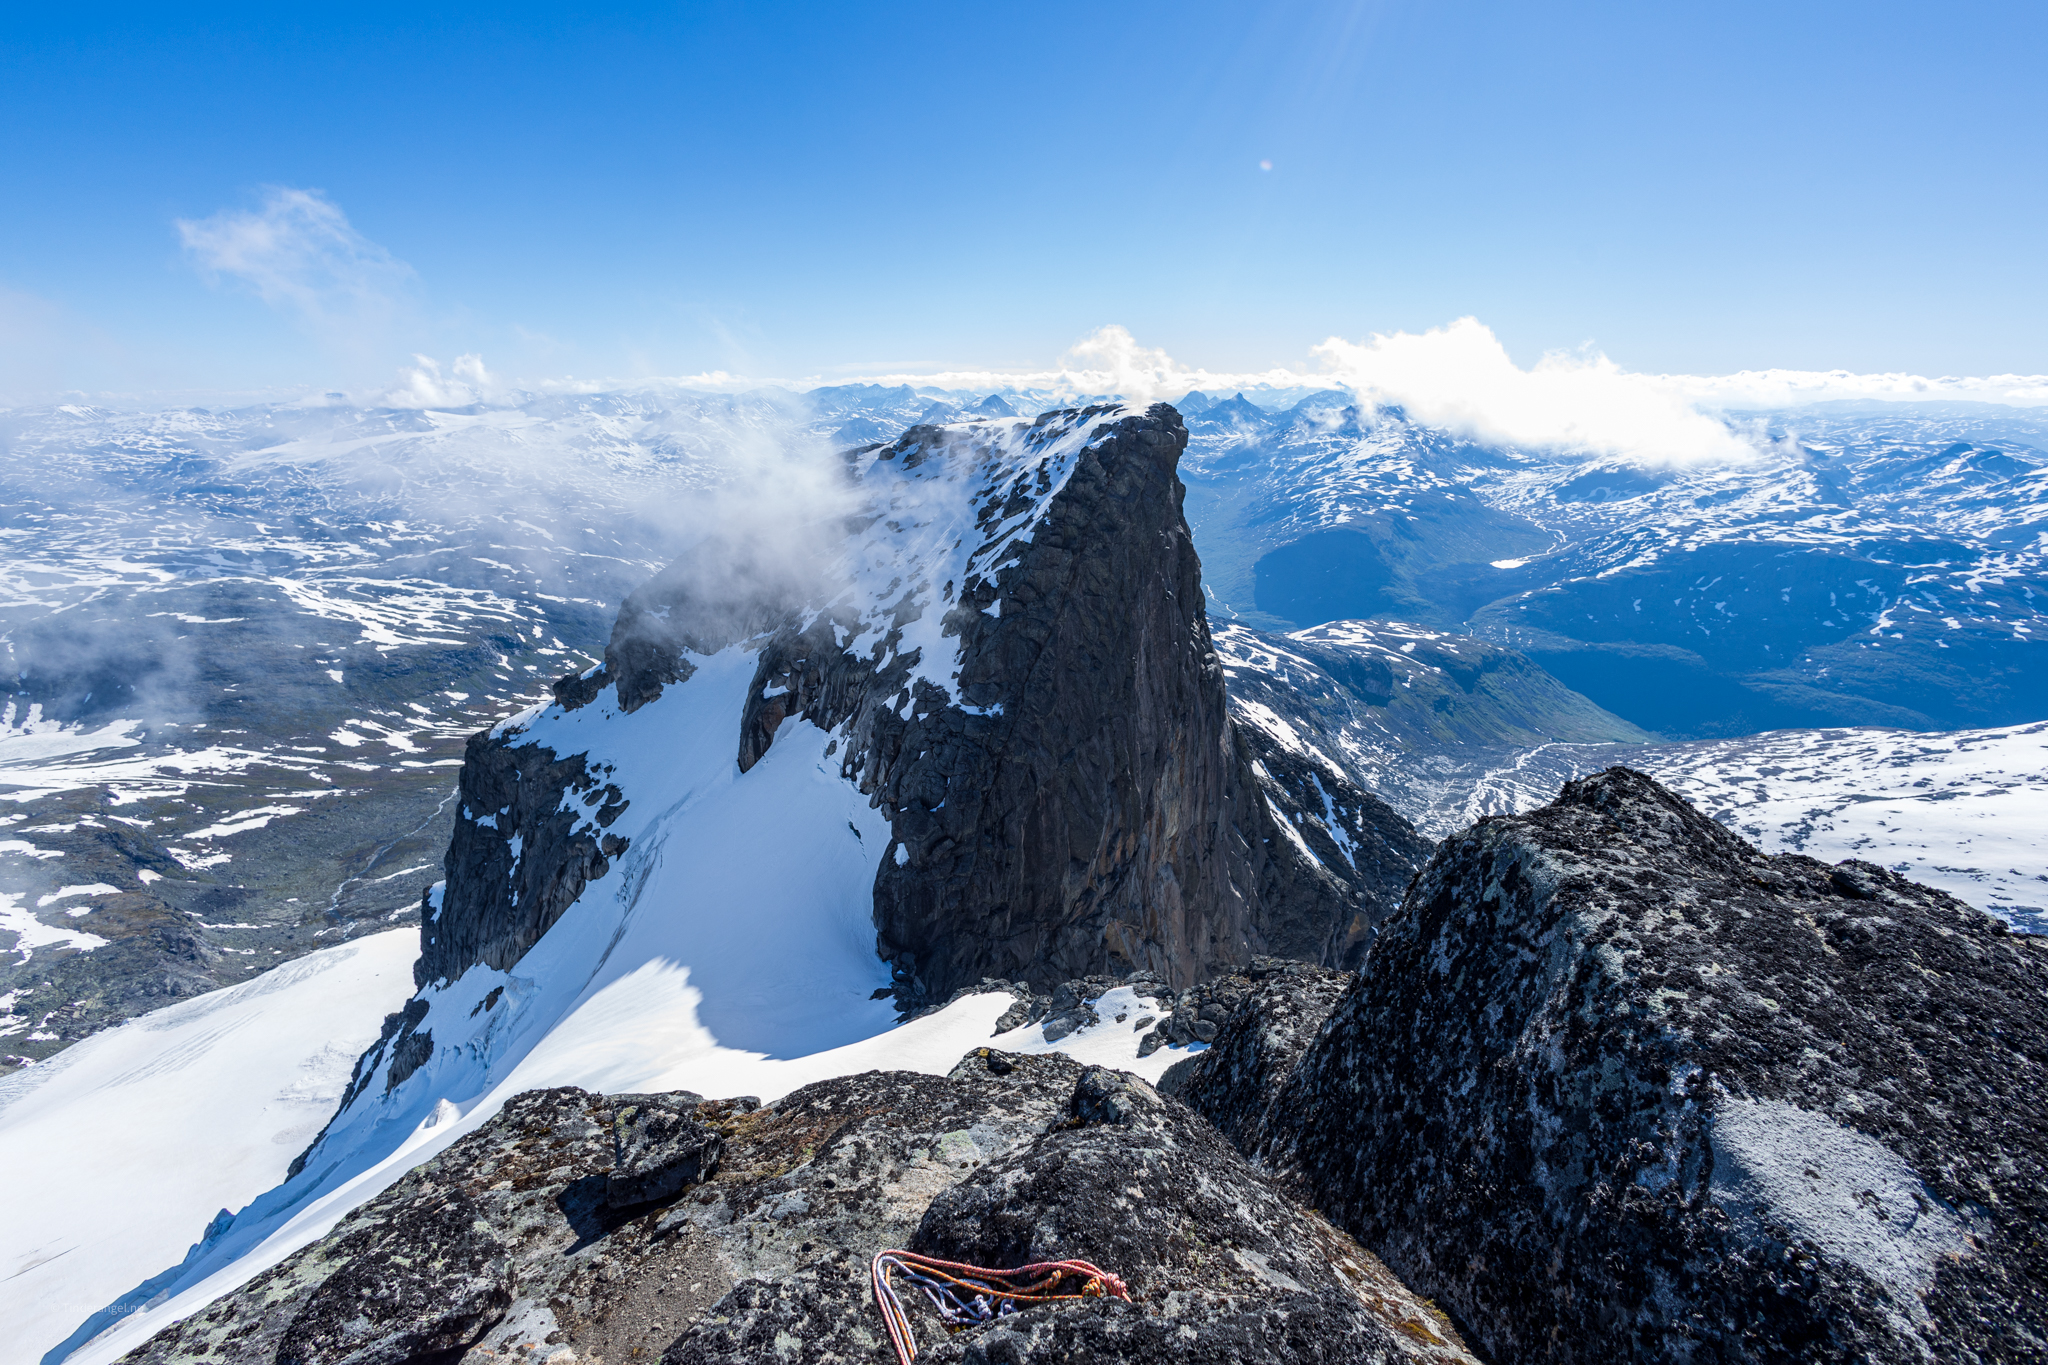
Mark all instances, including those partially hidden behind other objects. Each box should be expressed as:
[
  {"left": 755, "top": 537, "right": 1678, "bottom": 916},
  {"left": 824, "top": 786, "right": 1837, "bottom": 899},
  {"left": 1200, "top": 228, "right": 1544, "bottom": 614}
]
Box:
[{"left": 1245, "top": 767, "right": 2048, "bottom": 1361}]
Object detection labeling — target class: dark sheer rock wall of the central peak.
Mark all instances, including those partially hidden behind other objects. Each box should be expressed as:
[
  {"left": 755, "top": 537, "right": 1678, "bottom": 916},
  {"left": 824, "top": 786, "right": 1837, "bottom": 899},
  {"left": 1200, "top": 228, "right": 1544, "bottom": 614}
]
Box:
[{"left": 739, "top": 407, "right": 1364, "bottom": 1005}]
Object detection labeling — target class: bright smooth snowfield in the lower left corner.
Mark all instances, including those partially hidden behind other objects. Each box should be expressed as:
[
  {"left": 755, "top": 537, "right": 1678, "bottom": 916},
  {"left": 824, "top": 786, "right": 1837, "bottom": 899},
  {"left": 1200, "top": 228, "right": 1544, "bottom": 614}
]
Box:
[{"left": 0, "top": 929, "right": 418, "bottom": 1361}]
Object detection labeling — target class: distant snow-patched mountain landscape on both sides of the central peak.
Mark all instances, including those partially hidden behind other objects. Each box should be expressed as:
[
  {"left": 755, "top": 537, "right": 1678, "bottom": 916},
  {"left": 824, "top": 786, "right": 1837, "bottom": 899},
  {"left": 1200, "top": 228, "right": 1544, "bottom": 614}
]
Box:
[{"left": 0, "top": 385, "right": 2048, "bottom": 1066}]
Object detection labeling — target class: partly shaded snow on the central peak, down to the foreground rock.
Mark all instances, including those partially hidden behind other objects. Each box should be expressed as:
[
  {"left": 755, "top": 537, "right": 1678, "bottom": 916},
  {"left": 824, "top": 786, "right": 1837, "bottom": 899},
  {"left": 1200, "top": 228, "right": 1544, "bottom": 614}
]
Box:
[{"left": 44, "top": 409, "right": 1212, "bottom": 1361}]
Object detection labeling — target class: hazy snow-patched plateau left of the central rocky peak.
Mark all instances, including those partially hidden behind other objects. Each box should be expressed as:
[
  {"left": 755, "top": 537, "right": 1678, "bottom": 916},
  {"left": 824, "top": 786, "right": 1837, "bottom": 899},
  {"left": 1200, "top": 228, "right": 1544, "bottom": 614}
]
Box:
[{"left": 0, "top": 387, "right": 999, "bottom": 1070}]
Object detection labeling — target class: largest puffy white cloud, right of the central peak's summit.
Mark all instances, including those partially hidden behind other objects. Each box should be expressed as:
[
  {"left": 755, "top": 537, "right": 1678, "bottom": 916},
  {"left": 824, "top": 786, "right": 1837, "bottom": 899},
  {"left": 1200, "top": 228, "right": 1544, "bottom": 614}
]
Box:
[{"left": 1315, "top": 317, "right": 1753, "bottom": 463}]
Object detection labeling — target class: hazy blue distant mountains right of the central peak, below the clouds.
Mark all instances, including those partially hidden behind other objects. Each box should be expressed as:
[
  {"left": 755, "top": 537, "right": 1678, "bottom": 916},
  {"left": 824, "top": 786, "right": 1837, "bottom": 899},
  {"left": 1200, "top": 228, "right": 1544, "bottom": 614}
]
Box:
[{"left": 1186, "top": 395, "right": 2048, "bottom": 737}]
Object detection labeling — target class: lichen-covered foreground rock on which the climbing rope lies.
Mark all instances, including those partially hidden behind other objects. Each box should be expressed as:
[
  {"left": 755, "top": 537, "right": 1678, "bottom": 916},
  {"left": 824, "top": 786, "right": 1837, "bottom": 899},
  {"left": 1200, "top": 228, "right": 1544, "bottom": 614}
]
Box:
[{"left": 127, "top": 1050, "right": 1473, "bottom": 1365}]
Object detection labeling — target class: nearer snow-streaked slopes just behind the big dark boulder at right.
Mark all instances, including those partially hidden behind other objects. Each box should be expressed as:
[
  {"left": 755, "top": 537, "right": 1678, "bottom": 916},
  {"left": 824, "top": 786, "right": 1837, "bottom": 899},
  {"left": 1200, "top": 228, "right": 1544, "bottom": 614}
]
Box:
[{"left": 1217, "top": 620, "right": 2048, "bottom": 933}]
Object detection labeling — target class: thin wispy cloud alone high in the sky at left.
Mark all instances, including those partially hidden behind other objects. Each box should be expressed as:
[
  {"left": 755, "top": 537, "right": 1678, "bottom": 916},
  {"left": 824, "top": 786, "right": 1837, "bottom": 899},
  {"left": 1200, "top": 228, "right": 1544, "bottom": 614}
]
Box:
[{"left": 178, "top": 186, "right": 414, "bottom": 342}]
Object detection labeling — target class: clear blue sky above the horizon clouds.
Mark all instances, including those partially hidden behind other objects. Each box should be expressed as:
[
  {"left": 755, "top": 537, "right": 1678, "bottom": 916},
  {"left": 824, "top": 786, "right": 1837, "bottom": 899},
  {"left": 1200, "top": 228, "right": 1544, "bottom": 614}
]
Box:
[{"left": 0, "top": 0, "right": 2048, "bottom": 401}]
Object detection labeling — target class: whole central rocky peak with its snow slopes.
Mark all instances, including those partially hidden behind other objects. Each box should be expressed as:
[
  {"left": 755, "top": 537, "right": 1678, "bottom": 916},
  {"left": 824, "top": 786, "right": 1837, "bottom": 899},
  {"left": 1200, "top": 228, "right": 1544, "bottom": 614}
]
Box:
[{"left": 12, "top": 403, "right": 1427, "bottom": 1359}]
